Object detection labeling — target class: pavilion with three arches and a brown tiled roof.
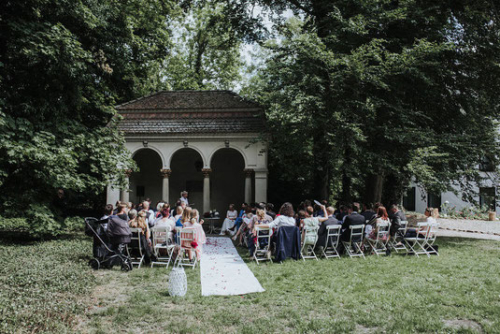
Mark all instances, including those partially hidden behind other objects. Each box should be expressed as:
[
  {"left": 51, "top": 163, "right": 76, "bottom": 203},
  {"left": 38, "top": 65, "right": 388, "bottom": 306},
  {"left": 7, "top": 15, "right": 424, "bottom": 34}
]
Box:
[{"left": 107, "top": 91, "right": 267, "bottom": 213}]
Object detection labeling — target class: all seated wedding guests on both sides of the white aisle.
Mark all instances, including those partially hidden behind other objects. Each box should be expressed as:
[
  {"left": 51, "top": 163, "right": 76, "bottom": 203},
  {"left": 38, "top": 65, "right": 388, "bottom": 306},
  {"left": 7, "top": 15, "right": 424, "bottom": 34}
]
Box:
[{"left": 101, "top": 192, "right": 435, "bottom": 263}]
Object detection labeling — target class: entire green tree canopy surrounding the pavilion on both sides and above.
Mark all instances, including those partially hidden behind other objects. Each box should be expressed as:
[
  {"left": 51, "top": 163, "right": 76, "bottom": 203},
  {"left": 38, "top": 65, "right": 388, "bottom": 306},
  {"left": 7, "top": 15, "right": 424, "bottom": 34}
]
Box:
[{"left": 0, "top": 0, "right": 500, "bottom": 232}]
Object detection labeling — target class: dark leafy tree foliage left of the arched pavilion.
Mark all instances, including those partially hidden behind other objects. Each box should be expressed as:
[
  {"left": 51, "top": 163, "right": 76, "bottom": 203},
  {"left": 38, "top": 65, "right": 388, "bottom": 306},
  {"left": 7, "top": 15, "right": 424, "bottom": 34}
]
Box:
[{"left": 0, "top": 0, "right": 175, "bottom": 234}]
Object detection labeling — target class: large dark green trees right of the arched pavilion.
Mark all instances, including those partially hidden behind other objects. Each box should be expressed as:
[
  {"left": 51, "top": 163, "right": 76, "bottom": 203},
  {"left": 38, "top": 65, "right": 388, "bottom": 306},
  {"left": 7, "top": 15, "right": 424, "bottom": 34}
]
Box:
[{"left": 244, "top": 0, "right": 500, "bottom": 202}]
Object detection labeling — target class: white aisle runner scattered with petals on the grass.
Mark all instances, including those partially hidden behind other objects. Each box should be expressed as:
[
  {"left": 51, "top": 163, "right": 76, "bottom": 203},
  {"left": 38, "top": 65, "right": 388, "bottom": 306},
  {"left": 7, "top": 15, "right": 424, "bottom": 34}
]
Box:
[{"left": 200, "top": 237, "right": 265, "bottom": 296}]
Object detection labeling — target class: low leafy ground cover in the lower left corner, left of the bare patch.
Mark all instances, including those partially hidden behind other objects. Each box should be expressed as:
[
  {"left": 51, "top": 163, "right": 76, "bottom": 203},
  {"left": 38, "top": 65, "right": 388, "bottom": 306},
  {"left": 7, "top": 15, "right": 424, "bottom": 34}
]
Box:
[{"left": 0, "top": 236, "right": 96, "bottom": 333}]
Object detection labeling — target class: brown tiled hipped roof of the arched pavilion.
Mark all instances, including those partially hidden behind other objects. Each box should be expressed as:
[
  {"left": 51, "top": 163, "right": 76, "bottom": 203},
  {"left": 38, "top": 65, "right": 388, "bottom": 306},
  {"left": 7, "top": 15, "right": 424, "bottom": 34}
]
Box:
[{"left": 116, "top": 91, "right": 264, "bottom": 134}]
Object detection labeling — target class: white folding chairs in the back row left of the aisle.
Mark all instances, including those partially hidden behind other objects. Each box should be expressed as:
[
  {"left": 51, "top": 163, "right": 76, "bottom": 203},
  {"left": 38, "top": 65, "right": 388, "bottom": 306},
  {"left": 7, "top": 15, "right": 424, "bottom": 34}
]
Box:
[{"left": 127, "top": 226, "right": 198, "bottom": 269}]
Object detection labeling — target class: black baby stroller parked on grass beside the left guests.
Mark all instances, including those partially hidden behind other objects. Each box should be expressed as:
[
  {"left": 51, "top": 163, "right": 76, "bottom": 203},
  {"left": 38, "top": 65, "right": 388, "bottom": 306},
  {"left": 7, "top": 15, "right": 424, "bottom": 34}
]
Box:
[{"left": 85, "top": 217, "right": 132, "bottom": 271}]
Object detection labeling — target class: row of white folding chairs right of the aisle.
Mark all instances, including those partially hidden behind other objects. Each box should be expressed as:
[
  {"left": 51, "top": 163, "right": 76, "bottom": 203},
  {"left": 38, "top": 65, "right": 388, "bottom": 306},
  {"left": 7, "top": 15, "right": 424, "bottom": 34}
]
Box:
[{"left": 253, "top": 221, "right": 439, "bottom": 263}]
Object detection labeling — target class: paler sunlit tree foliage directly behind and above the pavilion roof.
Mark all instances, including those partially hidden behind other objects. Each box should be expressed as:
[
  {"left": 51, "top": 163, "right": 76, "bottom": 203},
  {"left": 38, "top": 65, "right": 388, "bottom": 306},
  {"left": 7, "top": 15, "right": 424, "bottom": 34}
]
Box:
[{"left": 161, "top": 1, "right": 250, "bottom": 90}]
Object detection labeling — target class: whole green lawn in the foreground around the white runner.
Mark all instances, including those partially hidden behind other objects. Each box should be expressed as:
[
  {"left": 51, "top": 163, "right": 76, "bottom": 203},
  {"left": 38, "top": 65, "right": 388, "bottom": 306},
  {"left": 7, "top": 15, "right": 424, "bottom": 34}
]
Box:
[{"left": 0, "top": 237, "right": 500, "bottom": 334}]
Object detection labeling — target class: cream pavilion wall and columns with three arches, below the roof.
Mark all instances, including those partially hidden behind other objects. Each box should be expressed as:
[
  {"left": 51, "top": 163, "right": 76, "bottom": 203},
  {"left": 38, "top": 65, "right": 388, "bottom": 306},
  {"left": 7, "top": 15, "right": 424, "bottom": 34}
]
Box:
[{"left": 108, "top": 133, "right": 267, "bottom": 213}]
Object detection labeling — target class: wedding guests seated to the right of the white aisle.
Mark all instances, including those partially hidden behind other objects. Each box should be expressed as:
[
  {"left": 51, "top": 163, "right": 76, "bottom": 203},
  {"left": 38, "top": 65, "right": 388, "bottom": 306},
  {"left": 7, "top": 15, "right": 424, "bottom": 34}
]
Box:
[{"left": 217, "top": 201, "right": 436, "bottom": 256}]
